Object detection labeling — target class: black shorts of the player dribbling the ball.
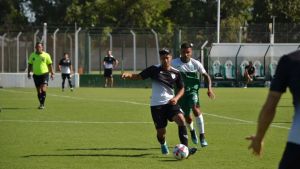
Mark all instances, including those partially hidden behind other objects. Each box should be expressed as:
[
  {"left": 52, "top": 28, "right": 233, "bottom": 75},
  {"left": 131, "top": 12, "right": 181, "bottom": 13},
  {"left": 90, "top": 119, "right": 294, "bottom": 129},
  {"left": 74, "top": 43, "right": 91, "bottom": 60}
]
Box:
[{"left": 151, "top": 104, "right": 182, "bottom": 129}]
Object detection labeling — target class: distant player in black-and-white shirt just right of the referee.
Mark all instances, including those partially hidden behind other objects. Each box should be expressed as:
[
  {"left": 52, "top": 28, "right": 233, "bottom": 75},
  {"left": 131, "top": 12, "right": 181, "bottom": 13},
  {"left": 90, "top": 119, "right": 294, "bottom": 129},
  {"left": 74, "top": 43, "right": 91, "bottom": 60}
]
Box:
[{"left": 58, "top": 53, "right": 73, "bottom": 91}]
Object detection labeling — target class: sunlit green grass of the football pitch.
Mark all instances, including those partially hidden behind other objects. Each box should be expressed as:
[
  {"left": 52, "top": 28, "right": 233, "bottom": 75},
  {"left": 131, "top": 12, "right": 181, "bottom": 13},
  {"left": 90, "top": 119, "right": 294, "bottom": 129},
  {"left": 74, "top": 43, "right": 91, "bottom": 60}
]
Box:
[{"left": 0, "top": 88, "right": 293, "bottom": 169}]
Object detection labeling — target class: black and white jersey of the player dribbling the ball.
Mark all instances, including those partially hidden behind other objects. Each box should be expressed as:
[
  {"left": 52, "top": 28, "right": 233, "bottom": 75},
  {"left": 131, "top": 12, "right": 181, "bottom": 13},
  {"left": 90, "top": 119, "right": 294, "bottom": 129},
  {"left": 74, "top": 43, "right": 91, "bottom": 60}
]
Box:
[{"left": 140, "top": 65, "right": 183, "bottom": 106}]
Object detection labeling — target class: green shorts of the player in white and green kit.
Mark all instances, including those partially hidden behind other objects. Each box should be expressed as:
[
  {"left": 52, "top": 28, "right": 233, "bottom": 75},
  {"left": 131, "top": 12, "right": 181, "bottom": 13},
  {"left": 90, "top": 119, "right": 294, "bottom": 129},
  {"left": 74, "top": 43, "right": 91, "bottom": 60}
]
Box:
[{"left": 178, "top": 91, "right": 200, "bottom": 116}]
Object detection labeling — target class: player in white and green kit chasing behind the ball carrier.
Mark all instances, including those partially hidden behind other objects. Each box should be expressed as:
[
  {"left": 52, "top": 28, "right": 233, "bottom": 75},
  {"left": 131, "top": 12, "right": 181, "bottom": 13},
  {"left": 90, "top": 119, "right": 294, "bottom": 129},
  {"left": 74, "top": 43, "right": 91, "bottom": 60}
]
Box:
[{"left": 172, "top": 43, "right": 215, "bottom": 147}]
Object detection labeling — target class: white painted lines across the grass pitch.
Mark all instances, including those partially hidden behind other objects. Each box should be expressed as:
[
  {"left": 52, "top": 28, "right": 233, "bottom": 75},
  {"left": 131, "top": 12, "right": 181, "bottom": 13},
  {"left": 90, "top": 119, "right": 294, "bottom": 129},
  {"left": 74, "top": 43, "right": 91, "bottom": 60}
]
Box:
[{"left": 0, "top": 89, "right": 290, "bottom": 130}]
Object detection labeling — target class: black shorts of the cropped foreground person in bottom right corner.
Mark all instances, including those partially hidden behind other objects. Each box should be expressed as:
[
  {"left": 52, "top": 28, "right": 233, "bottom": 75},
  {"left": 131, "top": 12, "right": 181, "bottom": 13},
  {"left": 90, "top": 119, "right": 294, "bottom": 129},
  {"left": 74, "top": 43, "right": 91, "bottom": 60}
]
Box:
[{"left": 279, "top": 142, "right": 300, "bottom": 169}]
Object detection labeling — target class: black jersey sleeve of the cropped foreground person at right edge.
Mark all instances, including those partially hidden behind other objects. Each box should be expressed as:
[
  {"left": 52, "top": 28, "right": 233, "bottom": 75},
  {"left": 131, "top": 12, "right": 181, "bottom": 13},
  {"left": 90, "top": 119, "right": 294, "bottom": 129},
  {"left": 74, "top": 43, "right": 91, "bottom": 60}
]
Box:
[{"left": 270, "top": 56, "right": 289, "bottom": 93}]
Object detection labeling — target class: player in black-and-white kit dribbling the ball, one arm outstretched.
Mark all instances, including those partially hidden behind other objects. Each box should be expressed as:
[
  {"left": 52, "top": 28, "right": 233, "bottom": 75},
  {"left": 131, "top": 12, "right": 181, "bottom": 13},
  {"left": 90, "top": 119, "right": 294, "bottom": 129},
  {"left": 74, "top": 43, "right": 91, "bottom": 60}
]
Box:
[{"left": 122, "top": 48, "right": 197, "bottom": 154}]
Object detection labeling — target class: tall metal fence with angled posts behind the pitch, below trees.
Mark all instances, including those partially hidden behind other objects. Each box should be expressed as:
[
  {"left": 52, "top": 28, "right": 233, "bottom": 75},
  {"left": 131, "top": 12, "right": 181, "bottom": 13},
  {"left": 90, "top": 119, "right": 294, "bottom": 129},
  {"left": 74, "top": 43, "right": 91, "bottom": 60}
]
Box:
[{"left": 0, "top": 24, "right": 300, "bottom": 74}]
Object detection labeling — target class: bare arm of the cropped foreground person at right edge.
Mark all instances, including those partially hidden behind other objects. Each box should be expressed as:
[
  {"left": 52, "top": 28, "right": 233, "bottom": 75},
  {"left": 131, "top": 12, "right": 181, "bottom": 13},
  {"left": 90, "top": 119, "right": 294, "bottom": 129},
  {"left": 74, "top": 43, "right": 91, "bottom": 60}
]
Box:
[{"left": 246, "top": 91, "right": 282, "bottom": 155}]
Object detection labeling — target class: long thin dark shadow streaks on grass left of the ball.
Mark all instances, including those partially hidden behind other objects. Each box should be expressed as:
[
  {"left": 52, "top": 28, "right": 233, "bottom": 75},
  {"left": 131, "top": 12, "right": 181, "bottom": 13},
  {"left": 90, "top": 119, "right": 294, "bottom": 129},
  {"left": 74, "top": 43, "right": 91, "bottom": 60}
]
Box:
[{"left": 22, "top": 147, "right": 158, "bottom": 158}]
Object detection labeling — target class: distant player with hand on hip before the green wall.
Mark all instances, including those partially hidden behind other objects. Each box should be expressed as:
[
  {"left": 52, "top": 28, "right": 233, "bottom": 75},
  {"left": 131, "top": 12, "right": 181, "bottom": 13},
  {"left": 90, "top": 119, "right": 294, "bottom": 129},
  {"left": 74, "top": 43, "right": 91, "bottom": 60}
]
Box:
[{"left": 103, "top": 50, "right": 119, "bottom": 87}]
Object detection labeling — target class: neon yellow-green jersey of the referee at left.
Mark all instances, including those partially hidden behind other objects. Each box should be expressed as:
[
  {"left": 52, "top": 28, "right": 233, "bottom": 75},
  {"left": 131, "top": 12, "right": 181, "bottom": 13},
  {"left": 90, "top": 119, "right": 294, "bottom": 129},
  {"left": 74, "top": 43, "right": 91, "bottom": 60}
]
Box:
[{"left": 28, "top": 52, "right": 52, "bottom": 75}]
